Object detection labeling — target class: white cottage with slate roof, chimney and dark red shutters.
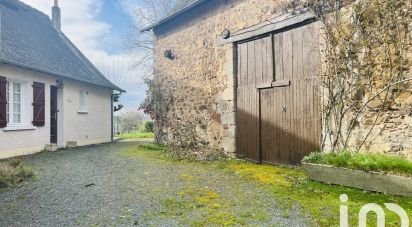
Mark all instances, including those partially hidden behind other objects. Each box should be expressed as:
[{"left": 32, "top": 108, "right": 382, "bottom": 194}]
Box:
[{"left": 0, "top": 0, "right": 124, "bottom": 159}]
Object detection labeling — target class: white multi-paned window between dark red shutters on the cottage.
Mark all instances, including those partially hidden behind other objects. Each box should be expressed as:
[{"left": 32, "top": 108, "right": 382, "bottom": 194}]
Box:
[{"left": 6, "top": 81, "right": 23, "bottom": 125}]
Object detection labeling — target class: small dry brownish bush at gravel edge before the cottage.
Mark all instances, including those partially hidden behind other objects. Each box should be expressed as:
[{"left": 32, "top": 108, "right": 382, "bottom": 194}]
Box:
[{"left": 0, "top": 159, "right": 33, "bottom": 188}]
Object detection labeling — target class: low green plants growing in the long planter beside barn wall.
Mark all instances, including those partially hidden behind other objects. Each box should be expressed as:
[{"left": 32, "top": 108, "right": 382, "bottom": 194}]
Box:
[{"left": 303, "top": 151, "right": 412, "bottom": 177}]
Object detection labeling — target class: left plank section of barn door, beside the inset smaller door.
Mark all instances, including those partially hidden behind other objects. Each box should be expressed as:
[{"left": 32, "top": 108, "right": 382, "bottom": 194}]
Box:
[{"left": 236, "top": 35, "right": 273, "bottom": 162}]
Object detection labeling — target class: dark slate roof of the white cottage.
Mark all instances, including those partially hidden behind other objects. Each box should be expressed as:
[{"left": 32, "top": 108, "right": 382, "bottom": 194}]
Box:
[{"left": 0, "top": 0, "right": 123, "bottom": 91}]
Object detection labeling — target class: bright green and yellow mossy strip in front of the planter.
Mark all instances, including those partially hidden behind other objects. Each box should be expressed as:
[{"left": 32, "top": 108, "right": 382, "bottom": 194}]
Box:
[{"left": 227, "top": 162, "right": 412, "bottom": 226}]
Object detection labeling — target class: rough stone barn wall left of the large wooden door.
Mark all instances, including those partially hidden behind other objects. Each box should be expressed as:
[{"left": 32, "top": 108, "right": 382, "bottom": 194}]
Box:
[{"left": 154, "top": 0, "right": 296, "bottom": 156}]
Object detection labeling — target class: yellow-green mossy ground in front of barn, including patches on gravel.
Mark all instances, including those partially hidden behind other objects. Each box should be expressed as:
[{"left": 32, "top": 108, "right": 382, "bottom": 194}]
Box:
[{"left": 122, "top": 144, "right": 412, "bottom": 226}]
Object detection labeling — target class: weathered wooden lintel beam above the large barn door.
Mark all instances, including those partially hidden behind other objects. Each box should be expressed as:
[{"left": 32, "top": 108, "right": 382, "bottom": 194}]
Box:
[{"left": 217, "top": 10, "right": 316, "bottom": 46}]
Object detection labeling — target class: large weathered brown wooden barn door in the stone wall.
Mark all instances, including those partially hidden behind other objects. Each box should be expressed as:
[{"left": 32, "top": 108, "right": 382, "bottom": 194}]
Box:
[{"left": 237, "top": 23, "right": 321, "bottom": 164}]
